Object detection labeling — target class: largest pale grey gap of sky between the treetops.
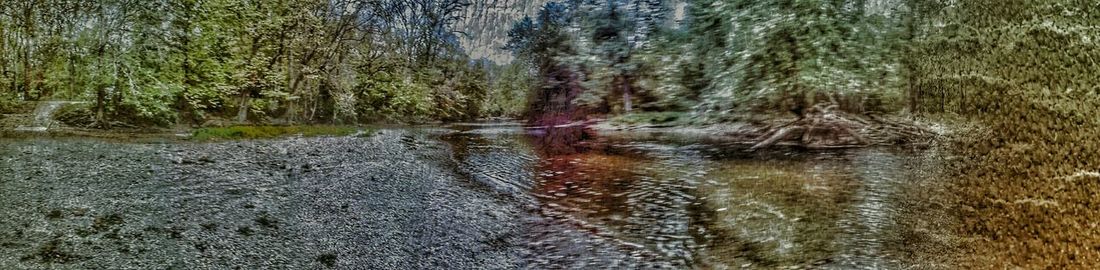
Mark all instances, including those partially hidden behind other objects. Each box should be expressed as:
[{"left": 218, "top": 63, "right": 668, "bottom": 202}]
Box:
[{"left": 458, "top": 0, "right": 549, "bottom": 64}]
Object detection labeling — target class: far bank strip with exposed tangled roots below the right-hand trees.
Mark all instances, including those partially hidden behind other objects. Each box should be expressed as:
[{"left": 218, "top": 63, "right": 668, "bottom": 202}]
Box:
[{"left": 591, "top": 112, "right": 950, "bottom": 149}]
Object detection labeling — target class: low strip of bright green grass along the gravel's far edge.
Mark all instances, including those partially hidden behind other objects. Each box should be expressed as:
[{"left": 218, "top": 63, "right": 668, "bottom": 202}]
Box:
[{"left": 191, "top": 126, "right": 363, "bottom": 141}]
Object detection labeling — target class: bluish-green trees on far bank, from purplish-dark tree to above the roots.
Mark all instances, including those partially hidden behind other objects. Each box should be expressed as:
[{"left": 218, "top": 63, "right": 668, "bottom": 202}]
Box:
[{"left": 508, "top": 0, "right": 906, "bottom": 118}]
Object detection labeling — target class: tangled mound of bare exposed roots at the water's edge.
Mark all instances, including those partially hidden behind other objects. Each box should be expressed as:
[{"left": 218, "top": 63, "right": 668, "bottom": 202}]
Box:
[{"left": 749, "top": 104, "right": 935, "bottom": 151}]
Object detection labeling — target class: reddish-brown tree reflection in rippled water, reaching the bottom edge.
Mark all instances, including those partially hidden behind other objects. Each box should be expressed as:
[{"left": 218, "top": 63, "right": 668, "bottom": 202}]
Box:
[{"left": 527, "top": 127, "right": 656, "bottom": 268}]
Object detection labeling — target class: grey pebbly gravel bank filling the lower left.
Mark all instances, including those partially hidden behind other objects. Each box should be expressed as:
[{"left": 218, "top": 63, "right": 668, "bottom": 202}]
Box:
[{"left": 0, "top": 130, "right": 530, "bottom": 269}]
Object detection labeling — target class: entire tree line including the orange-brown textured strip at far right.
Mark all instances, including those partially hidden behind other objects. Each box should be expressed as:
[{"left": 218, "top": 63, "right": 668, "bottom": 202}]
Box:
[{"left": 0, "top": 0, "right": 1100, "bottom": 268}]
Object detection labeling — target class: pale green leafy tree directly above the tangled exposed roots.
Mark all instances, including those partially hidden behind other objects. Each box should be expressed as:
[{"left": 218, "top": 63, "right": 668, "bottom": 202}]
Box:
[{"left": 695, "top": 0, "right": 900, "bottom": 115}]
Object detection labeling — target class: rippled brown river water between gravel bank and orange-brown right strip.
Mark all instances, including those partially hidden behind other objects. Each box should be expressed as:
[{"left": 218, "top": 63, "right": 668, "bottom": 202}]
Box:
[{"left": 448, "top": 123, "right": 944, "bottom": 269}]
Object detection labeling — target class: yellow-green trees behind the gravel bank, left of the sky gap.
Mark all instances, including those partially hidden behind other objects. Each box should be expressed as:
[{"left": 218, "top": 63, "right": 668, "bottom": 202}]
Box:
[{"left": 0, "top": 0, "right": 488, "bottom": 128}]
